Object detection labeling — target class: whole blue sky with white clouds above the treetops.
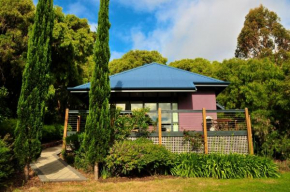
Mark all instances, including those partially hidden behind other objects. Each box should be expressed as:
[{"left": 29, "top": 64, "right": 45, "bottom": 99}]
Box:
[{"left": 33, "top": 0, "right": 290, "bottom": 62}]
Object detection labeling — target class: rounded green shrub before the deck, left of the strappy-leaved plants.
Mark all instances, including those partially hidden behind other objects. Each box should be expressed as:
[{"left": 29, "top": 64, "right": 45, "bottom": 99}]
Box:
[{"left": 105, "top": 138, "right": 175, "bottom": 175}]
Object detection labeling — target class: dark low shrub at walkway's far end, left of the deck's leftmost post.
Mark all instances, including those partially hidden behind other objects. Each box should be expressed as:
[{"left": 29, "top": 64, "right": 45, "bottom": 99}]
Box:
[{"left": 41, "top": 124, "right": 63, "bottom": 143}]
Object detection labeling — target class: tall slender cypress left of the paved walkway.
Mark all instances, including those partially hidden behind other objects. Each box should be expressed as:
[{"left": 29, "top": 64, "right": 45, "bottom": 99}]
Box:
[{"left": 15, "top": 0, "right": 54, "bottom": 181}]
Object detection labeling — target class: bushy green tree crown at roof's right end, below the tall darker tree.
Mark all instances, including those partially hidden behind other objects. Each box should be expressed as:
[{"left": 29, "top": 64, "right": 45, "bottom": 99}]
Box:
[{"left": 215, "top": 59, "right": 284, "bottom": 113}]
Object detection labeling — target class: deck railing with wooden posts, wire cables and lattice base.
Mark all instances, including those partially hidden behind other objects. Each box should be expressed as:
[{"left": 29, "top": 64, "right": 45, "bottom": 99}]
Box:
[{"left": 64, "top": 109, "right": 253, "bottom": 154}]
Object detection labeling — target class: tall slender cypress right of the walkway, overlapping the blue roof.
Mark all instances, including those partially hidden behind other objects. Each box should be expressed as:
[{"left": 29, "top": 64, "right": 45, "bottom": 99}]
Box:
[{"left": 76, "top": 0, "right": 111, "bottom": 178}]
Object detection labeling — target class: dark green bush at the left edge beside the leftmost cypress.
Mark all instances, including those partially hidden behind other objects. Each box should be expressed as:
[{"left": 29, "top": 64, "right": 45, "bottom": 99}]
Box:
[{"left": 0, "top": 136, "right": 14, "bottom": 184}]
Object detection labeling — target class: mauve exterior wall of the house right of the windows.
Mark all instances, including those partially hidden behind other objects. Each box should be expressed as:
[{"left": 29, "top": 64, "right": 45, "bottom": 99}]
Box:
[{"left": 178, "top": 91, "right": 216, "bottom": 131}]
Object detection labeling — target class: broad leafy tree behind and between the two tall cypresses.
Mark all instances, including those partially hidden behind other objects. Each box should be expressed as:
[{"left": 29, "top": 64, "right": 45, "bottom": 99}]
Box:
[{"left": 46, "top": 6, "right": 96, "bottom": 123}]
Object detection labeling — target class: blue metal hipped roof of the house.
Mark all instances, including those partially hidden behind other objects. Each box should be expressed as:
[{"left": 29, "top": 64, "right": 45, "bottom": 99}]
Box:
[{"left": 69, "top": 63, "right": 229, "bottom": 90}]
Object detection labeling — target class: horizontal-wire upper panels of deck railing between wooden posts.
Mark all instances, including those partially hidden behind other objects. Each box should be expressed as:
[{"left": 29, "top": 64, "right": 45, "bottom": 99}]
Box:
[{"left": 68, "top": 109, "right": 247, "bottom": 132}]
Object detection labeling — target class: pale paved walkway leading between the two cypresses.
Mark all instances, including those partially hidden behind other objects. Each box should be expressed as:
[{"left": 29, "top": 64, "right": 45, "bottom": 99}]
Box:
[{"left": 31, "top": 145, "right": 87, "bottom": 182}]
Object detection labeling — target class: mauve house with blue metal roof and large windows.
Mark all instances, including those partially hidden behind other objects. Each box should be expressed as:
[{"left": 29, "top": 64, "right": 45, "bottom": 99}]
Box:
[{"left": 68, "top": 63, "right": 229, "bottom": 132}]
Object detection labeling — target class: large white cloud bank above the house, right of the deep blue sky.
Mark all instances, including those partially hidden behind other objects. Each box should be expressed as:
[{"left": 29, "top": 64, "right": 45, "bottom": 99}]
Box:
[{"left": 127, "top": 0, "right": 290, "bottom": 61}]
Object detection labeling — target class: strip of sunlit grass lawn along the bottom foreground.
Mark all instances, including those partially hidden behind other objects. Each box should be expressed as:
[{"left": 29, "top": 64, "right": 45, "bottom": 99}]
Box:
[{"left": 11, "top": 172, "right": 290, "bottom": 192}]
